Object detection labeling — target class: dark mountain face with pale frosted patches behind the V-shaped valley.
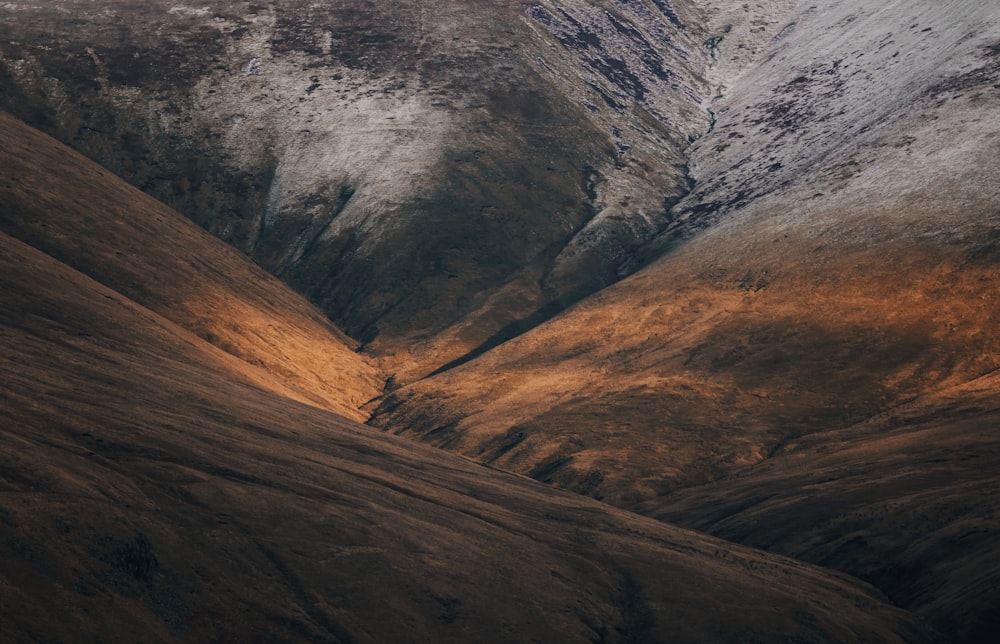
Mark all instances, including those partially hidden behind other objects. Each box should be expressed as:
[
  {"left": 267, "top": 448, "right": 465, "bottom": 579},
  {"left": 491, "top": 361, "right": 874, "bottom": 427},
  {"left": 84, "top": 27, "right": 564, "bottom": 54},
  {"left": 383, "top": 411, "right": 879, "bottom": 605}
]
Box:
[{"left": 0, "top": 0, "right": 764, "bottom": 380}]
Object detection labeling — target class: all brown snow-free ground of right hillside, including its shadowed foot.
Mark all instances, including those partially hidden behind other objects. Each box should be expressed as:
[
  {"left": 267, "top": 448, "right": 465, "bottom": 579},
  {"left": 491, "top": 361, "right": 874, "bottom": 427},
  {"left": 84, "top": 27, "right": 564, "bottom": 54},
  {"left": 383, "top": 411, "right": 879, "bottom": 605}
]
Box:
[{"left": 377, "top": 208, "right": 1000, "bottom": 641}]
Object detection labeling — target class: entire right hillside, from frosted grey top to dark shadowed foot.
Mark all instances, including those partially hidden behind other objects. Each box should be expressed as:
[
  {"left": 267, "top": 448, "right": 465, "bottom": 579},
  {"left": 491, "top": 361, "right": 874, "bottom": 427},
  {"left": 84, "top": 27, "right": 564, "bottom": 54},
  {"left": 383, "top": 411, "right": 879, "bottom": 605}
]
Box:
[{"left": 376, "top": 2, "right": 1000, "bottom": 641}]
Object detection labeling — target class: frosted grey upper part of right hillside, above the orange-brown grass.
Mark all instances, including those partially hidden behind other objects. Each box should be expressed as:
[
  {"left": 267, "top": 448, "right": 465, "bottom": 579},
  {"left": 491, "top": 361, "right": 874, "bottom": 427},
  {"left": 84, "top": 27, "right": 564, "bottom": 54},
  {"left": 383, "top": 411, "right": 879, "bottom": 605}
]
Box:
[{"left": 660, "top": 1, "right": 1000, "bottom": 255}]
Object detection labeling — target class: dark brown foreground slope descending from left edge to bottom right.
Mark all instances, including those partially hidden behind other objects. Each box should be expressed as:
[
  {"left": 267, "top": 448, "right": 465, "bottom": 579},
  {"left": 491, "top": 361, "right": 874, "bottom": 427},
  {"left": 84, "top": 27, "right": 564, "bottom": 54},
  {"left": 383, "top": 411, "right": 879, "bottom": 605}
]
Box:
[{"left": 0, "top": 233, "right": 922, "bottom": 642}]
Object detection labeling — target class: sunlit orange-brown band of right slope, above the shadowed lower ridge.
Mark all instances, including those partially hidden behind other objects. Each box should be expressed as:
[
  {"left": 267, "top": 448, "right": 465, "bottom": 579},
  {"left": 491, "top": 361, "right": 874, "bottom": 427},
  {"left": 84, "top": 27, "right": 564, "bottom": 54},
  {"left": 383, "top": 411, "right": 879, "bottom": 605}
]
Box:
[{"left": 377, "top": 229, "right": 1000, "bottom": 506}]
